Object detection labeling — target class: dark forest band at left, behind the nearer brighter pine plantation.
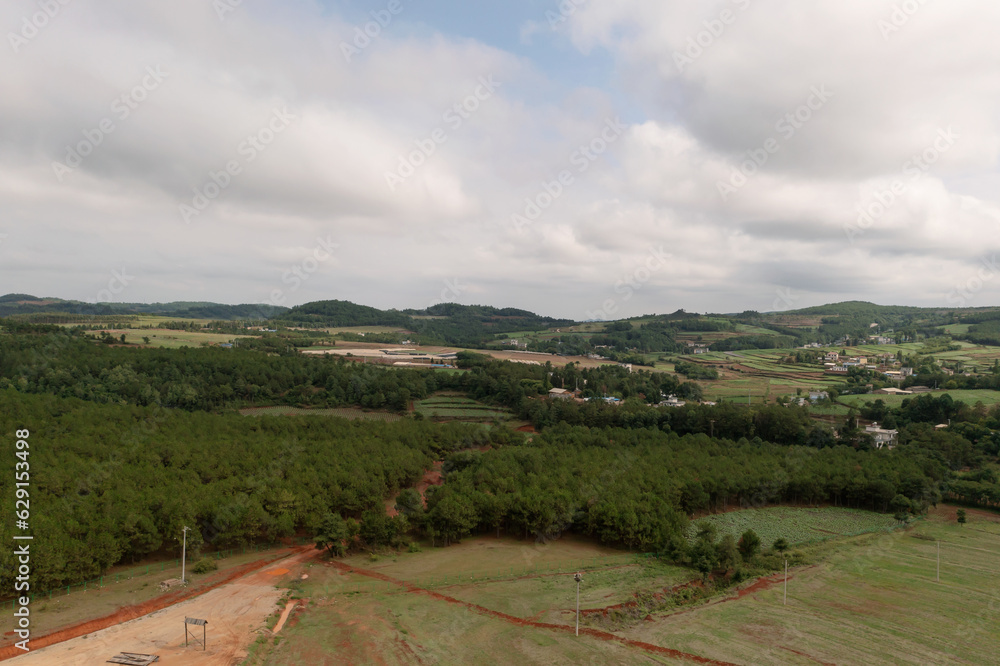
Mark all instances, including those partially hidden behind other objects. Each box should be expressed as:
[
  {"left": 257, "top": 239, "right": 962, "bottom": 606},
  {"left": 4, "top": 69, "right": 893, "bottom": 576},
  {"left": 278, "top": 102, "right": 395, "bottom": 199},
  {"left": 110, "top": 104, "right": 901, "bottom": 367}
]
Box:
[{"left": 0, "top": 322, "right": 448, "bottom": 410}]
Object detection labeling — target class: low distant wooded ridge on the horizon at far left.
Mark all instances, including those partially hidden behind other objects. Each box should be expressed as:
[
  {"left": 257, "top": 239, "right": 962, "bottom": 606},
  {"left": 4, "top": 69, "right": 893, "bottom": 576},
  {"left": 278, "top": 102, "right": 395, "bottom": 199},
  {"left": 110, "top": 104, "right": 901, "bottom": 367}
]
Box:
[{"left": 0, "top": 294, "right": 288, "bottom": 321}]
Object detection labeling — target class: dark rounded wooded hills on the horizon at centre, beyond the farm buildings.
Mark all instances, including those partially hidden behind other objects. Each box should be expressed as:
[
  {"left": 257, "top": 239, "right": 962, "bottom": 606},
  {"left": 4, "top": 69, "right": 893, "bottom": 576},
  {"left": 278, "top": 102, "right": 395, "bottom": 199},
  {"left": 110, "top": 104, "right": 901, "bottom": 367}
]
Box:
[{"left": 274, "top": 300, "right": 573, "bottom": 347}]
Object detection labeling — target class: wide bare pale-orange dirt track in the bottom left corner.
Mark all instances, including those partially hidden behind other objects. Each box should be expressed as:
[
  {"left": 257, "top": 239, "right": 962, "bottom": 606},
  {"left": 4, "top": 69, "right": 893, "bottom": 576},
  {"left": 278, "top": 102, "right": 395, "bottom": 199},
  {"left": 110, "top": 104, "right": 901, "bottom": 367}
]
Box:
[{"left": 0, "top": 549, "right": 319, "bottom": 666}]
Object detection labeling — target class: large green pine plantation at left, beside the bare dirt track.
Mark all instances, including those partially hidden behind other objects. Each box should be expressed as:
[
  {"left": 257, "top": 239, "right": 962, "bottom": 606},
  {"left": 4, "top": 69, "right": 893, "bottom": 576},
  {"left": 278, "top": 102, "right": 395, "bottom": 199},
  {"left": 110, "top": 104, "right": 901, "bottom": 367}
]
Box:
[{"left": 0, "top": 390, "right": 520, "bottom": 591}]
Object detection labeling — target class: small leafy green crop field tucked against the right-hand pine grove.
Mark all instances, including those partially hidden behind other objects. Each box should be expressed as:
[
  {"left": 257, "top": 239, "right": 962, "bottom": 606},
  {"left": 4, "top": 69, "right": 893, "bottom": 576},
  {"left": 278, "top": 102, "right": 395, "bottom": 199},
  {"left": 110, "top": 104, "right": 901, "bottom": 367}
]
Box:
[{"left": 688, "top": 506, "right": 899, "bottom": 548}]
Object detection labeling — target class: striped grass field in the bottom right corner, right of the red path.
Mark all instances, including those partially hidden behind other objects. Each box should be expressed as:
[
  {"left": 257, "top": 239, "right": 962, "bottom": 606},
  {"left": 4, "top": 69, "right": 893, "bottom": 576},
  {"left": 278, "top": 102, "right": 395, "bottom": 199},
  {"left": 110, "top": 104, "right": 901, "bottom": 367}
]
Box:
[{"left": 625, "top": 507, "right": 1000, "bottom": 665}]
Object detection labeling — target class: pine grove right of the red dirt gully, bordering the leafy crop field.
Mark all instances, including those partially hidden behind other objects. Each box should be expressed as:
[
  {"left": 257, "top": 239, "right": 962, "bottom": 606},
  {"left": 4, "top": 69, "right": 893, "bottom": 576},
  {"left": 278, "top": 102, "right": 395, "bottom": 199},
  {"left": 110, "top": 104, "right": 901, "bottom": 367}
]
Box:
[{"left": 410, "top": 424, "right": 947, "bottom": 552}]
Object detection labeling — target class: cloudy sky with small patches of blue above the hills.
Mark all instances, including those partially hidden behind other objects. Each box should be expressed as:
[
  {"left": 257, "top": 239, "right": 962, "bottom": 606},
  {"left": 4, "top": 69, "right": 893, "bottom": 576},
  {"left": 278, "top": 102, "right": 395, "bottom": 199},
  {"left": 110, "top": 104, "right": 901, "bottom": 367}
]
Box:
[{"left": 0, "top": 0, "right": 1000, "bottom": 320}]
